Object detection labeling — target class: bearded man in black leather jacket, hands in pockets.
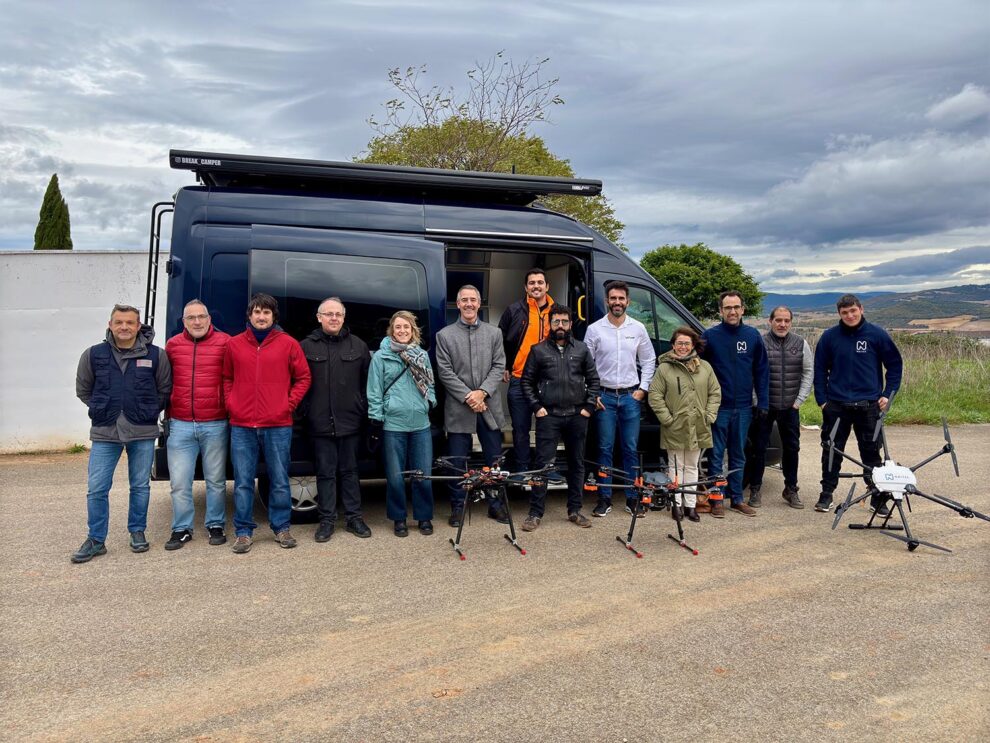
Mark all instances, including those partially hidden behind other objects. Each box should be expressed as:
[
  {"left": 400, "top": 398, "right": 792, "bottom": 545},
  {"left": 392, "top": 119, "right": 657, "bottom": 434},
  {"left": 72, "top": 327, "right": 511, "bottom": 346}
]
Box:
[{"left": 521, "top": 304, "right": 600, "bottom": 531}]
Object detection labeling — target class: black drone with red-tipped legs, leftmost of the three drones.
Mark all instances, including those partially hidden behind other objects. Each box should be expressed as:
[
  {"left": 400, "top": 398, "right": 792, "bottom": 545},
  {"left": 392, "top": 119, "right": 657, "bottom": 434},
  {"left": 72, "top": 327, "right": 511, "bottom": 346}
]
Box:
[{"left": 400, "top": 454, "right": 553, "bottom": 560}]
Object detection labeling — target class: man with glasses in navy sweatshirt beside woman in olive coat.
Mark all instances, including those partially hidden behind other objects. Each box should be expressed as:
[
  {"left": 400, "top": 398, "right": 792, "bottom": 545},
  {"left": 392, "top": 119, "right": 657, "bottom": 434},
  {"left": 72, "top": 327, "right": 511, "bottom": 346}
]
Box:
[{"left": 701, "top": 291, "right": 770, "bottom": 518}]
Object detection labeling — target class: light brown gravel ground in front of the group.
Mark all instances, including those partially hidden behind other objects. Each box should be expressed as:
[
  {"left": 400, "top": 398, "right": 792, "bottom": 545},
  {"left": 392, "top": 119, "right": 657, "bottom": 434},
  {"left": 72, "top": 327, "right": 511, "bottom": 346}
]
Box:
[{"left": 0, "top": 426, "right": 990, "bottom": 741}]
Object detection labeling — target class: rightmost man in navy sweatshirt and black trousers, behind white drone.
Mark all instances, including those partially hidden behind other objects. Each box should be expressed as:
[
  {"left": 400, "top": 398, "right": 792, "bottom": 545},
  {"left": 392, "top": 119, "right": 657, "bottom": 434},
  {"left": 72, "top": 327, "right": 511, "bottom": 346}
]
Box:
[{"left": 815, "top": 294, "right": 903, "bottom": 515}]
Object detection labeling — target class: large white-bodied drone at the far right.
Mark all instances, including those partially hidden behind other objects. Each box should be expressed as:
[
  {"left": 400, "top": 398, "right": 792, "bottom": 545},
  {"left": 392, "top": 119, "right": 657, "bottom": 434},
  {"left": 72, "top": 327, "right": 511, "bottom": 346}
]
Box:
[{"left": 823, "top": 395, "right": 990, "bottom": 552}]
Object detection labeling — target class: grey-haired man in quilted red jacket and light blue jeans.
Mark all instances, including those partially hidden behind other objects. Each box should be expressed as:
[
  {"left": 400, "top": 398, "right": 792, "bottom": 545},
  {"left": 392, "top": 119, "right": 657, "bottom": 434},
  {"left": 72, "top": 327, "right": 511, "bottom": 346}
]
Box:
[{"left": 165, "top": 299, "right": 230, "bottom": 550}]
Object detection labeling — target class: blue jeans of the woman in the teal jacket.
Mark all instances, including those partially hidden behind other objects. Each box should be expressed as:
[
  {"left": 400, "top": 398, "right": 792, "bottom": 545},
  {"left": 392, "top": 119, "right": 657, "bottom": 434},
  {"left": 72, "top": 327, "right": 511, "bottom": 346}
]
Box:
[{"left": 382, "top": 426, "right": 433, "bottom": 521}]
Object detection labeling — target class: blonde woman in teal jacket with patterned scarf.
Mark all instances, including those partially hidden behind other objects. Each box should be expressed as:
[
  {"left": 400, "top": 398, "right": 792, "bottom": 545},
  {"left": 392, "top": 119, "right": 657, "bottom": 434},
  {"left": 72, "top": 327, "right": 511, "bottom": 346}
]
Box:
[{"left": 368, "top": 310, "right": 437, "bottom": 537}]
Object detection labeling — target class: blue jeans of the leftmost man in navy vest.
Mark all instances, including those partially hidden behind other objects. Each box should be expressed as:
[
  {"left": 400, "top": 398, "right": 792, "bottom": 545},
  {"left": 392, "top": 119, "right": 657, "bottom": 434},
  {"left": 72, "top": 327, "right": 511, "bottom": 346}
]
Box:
[{"left": 86, "top": 439, "right": 155, "bottom": 542}]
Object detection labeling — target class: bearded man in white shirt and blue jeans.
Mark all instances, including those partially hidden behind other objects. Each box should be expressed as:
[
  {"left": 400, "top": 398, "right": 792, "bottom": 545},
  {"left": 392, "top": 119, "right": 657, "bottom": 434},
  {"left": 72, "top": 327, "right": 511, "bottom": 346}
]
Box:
[{"left": 584, "top": 281, "right": 657, "bottom": 517}]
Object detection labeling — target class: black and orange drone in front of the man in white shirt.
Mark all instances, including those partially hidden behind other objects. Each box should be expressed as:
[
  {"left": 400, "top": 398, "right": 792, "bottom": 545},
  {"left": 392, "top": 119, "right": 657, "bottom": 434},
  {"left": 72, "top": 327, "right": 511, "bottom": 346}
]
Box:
[{"left": 584, "top": 462, "right": 726, "bottom": 558}]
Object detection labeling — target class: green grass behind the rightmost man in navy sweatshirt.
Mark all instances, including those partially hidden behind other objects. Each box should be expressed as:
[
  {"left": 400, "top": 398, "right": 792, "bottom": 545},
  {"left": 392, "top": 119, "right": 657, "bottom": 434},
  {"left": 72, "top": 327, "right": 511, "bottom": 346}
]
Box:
[{"left": 801, "top": 333, "right": 990, "bottom": 426}]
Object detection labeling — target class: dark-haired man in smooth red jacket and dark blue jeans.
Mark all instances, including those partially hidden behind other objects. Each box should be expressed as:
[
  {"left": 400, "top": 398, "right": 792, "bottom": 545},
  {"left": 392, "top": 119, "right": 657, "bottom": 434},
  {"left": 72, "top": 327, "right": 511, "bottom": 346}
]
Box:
[{"left": 223, "top": 293, "right": 310, "bottom": 553}]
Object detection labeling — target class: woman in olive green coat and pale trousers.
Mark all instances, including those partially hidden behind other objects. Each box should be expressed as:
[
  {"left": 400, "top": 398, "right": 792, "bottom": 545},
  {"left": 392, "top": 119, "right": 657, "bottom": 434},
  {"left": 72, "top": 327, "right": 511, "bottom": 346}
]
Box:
[{"left": 649, "top": 326, "right": 722, "bottom": 521}]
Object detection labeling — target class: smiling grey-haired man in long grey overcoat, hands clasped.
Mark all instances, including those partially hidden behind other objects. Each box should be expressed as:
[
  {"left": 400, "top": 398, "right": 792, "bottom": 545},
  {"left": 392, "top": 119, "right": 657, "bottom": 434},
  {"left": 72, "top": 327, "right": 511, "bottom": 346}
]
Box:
[{"left": 437, "top": 284, "right": 508, "bottom": 527}]
